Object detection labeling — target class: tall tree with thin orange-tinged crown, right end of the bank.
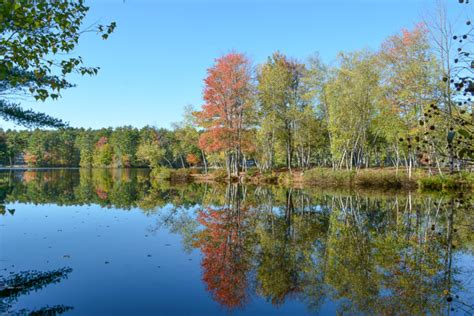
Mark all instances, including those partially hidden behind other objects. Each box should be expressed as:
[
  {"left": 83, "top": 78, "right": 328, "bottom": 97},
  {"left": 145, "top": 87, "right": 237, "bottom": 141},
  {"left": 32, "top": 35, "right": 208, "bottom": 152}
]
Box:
[{"left": 378, "top": 24, "right": 440, "bottom": 175}]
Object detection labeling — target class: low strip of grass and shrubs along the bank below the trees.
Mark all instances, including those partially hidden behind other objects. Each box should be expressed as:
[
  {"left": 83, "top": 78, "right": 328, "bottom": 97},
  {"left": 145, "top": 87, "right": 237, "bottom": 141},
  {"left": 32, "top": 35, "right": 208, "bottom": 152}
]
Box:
[{"left": 152, "top": 168, "right": 474, "bottom": 191}]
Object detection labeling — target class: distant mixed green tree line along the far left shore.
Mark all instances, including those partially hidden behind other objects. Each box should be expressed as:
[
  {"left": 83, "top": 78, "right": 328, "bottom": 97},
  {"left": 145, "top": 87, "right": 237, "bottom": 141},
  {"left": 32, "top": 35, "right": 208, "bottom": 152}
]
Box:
[{"left": 0, "top": 126, "right": 200, "bottom": 168}]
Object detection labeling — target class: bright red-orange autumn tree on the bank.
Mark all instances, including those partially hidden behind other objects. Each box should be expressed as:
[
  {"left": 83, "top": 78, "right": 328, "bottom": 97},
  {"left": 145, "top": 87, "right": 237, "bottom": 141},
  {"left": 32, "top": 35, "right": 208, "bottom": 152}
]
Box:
[{"left": 195, "top": 53, "right": 253, "bottom": 178}]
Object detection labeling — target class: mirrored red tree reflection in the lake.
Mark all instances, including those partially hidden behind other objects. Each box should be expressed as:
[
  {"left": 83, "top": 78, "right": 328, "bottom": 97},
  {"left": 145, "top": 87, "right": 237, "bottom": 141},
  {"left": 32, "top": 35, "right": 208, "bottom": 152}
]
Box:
[{"left": 195, "top": 208, "right": 248, "bottom": 308}]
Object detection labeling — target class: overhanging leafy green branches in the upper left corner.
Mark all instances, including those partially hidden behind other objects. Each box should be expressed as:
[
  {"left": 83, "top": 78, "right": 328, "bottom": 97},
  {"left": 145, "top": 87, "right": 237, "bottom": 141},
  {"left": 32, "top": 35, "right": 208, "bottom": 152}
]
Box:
[{"left": 0, "top": 0, "right": 116, "bottom": 127}]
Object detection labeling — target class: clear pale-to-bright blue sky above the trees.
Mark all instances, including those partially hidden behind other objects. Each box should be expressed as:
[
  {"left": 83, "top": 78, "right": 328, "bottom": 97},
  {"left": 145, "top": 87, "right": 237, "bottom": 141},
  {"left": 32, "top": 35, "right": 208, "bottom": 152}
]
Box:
[{"left": 0, "top": 0, "right": 468, "bottom": 128}]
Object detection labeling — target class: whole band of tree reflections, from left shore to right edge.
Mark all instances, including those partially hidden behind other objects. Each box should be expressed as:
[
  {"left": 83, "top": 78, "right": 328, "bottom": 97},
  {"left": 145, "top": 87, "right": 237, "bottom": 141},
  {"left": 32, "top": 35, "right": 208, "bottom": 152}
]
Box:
[{"left": 0, "top": 169, "right": 474, "bottom": 315}]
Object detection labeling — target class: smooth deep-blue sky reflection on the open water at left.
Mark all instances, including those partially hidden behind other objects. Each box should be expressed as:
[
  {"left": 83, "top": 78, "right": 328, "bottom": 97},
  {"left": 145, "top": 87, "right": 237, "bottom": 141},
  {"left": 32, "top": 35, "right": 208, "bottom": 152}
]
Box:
[{"left": 0, "top": 203, "right": 312, "bottom": 315}]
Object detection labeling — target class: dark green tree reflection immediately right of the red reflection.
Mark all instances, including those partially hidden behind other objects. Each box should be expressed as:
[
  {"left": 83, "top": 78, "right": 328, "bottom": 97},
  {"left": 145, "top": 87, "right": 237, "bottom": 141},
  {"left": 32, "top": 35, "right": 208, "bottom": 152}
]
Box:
[{"left": 256, "top": 185, "right": 325, "bottom": 304}]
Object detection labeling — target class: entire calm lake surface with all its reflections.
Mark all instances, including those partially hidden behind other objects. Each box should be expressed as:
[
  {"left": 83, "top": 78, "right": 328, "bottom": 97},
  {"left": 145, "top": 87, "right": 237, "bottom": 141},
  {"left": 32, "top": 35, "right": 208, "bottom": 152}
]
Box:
[{"left": 0, "top": 169, "right": 474, "bottom": 315}]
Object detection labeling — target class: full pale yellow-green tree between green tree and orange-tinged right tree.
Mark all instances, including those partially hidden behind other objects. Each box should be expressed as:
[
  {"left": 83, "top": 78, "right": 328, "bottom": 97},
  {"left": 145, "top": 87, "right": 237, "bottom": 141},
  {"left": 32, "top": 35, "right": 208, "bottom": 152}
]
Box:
[{"left": 326, "top": 51, "right": 380, "bottom": 169}]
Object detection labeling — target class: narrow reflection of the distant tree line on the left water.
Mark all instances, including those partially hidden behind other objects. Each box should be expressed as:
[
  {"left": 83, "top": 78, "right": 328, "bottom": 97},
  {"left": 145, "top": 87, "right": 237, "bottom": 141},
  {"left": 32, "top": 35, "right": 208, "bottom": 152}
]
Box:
[{"left": 2, "top": 169, "right": 209, "bottom": 212}]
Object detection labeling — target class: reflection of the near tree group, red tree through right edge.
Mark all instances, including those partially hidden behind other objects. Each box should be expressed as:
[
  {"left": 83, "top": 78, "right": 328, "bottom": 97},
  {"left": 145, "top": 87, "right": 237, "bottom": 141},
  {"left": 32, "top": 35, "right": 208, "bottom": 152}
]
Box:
[{"left": 190, "top": 184, "right": 472, "bottom": 314}]
